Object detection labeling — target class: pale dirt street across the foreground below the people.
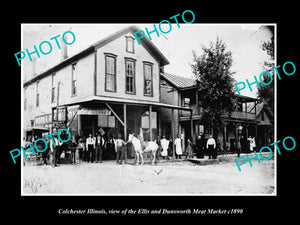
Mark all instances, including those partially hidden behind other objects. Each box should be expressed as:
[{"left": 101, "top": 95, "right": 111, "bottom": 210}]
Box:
[{"left": 22, "top": 155, "right": 275, "bottom": 195}]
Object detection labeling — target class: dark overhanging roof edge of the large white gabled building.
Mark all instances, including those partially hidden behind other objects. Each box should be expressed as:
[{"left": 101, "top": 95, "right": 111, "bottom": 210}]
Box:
[{"left": 23, "top": 26, "right": 170, "bottom": 87}]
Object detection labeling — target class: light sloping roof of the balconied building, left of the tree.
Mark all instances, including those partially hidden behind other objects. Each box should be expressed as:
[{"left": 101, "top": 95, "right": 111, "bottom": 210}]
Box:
[{"left": 160, "top": 73, "right": 197, "bottom": 89}]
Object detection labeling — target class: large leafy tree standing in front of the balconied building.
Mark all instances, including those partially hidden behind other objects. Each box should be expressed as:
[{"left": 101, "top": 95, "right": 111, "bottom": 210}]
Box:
[{"left": 191, "top": 38, "right": 236, "bottom": 135}]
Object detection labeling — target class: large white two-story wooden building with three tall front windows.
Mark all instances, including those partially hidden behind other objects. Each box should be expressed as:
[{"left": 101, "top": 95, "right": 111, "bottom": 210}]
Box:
[{"left": 23, "top": 26, "right": 191, "bottom": 157}]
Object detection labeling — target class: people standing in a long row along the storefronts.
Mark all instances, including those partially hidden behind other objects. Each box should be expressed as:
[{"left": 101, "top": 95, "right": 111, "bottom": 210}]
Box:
[{"left": 25, "top": 128, "right": 248, "bottom": 167}]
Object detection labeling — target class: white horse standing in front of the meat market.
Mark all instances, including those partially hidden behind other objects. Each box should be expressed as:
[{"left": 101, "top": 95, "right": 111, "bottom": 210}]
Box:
[{"left": 127, "top": 133, "right": 158, "bottom": 165}]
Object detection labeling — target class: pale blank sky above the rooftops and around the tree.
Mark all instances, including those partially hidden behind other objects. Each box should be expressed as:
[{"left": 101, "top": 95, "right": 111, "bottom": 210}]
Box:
[{"left": 21, "top": 23, "right": 271, "bottom": 97}]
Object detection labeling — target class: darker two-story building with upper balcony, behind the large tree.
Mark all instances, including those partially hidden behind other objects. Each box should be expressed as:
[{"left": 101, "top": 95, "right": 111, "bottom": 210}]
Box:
[{"left": 161, "top": 73, "right": 272, "bottom": 152}]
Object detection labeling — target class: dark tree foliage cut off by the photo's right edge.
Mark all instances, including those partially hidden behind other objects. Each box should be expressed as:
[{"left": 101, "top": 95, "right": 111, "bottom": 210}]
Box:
[{"left": 257, "top": 30, "right": 275, "bottom": 115}]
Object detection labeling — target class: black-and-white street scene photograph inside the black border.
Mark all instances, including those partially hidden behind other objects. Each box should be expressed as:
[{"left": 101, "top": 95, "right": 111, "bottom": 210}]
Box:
[{"left": 19, "top": 23, "right": 276, "bottom": 196}]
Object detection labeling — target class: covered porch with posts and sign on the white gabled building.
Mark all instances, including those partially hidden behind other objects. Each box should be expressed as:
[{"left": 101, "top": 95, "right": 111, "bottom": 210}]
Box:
[{"left": 52, "top": 96, "right": 191, "bottom": 160}]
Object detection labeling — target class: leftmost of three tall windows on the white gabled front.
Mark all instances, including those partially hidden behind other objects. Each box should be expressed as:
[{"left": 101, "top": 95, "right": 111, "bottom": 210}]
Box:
[{"left": 105, "top": 54, "right": 117, "bottom": 92}]
